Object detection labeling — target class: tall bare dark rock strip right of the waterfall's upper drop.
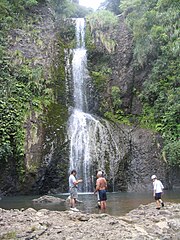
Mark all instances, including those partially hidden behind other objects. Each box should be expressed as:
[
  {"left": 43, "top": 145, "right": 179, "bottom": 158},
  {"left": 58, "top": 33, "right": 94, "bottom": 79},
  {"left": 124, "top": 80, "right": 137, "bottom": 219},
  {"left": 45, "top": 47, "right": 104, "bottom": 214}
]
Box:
[{"left": 111, "top": 15, "right": 151, "bottom": 115}]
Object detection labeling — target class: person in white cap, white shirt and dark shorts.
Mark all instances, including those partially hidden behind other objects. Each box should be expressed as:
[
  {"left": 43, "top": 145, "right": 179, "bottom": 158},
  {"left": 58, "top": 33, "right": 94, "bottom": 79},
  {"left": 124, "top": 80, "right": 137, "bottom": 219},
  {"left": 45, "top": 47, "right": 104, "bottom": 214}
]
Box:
[{"left": 151, "top": 175, "right": 164, "bottom": 209}]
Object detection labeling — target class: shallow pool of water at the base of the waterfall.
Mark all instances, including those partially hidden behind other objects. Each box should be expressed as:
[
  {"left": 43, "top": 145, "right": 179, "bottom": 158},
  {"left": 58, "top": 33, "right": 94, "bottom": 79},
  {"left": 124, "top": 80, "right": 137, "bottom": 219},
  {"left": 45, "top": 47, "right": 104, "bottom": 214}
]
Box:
[{"left": 0, "top": 190, "right": 180, "bottom": 216}]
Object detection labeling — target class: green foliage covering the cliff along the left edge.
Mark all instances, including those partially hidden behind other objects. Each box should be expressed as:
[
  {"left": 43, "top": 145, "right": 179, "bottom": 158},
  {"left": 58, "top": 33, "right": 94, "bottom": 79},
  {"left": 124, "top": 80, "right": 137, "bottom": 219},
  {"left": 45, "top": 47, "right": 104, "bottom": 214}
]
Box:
[{"left": 0, "top": 0, "right": 53, "bottom": 180}]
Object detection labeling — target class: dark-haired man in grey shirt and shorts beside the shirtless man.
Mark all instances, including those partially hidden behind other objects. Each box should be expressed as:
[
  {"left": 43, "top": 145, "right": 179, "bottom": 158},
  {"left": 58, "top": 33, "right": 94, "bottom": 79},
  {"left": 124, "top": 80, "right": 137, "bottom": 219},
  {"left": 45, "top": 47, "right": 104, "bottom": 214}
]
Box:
[{"left": 69, "top": 170, "right": 82, "bottom": 212}]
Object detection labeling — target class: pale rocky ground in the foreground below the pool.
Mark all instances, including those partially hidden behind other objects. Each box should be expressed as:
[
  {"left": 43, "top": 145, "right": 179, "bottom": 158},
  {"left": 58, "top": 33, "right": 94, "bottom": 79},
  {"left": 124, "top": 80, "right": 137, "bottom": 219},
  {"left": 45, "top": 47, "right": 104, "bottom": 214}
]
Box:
[{"left": 0, "top": 203, "right": 180, "bottom": 240}]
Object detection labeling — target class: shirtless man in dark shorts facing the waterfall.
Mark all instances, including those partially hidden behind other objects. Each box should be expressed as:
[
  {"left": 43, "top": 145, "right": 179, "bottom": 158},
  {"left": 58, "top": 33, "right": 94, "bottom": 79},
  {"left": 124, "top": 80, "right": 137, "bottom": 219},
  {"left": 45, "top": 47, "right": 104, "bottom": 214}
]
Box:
[{"left": 94, "top": 171, "right": 107, "bottom": 209}]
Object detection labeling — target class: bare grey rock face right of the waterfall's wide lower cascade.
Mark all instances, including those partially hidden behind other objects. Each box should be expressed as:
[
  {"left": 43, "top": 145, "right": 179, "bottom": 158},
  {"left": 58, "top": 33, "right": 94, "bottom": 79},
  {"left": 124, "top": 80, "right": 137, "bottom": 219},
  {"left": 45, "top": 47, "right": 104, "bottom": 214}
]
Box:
[{"left": 103, "top": 125, "right": 169, "bottom": 191}]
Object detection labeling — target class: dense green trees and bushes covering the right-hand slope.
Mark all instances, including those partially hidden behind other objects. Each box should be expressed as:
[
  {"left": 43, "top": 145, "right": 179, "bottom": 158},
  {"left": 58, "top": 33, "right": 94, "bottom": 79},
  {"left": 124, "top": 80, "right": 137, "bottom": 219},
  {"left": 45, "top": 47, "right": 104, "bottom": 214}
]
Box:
[{"left": 121, "top": 0, "right": 180, "bottom": 165}]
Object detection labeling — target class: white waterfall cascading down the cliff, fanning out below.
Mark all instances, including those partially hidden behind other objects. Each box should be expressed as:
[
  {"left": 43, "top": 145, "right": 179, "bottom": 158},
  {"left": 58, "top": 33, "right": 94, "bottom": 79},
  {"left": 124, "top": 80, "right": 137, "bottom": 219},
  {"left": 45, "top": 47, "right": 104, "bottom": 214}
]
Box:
[{"left": 68, "top": 19, "right": 120, "bottom": 192}]
